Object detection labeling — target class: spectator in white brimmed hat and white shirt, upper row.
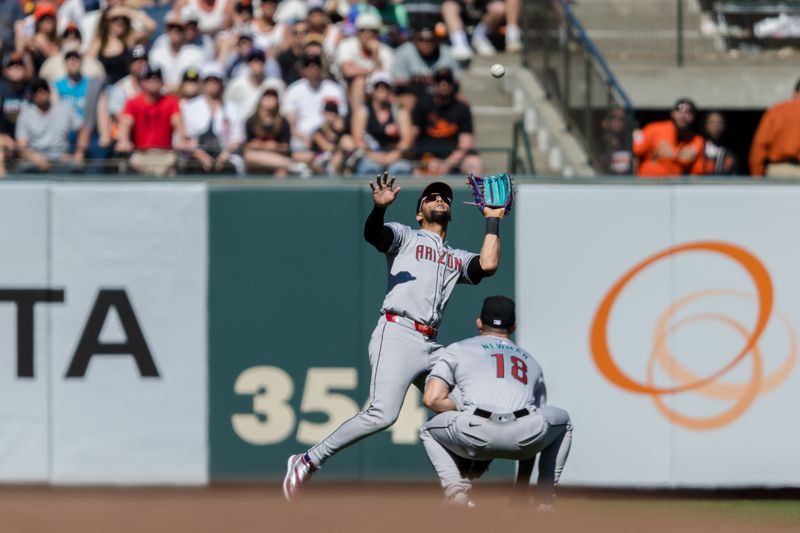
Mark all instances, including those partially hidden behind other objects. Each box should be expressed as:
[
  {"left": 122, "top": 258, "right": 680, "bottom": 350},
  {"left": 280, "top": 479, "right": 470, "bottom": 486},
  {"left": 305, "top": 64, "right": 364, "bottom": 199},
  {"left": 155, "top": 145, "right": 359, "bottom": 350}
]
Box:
[{"left": 336, "top": 12, "right": 394, "bottom": 109}]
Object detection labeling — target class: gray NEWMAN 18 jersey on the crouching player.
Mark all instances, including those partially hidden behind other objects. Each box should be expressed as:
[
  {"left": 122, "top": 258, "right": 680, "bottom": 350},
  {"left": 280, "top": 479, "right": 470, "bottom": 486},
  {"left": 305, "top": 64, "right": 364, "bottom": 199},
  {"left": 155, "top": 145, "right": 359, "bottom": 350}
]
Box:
[{"left": 428, "top": 335, "right": 547, "bottom": 413}]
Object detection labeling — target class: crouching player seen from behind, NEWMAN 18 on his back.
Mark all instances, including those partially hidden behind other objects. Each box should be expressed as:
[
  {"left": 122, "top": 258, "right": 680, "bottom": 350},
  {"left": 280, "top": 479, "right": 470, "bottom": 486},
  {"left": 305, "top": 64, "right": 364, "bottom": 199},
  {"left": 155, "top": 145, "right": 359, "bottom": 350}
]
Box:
[{"left": 420, "top": 296, "right": 572, "bottom": 511}]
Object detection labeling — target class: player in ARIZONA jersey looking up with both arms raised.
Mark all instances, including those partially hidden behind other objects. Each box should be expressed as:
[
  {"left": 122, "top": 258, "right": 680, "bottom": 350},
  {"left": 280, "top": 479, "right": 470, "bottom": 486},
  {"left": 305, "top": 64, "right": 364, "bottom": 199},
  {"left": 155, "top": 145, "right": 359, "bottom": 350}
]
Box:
[{"left": 283, "top": 173, "right": 504, "bottom": 502}]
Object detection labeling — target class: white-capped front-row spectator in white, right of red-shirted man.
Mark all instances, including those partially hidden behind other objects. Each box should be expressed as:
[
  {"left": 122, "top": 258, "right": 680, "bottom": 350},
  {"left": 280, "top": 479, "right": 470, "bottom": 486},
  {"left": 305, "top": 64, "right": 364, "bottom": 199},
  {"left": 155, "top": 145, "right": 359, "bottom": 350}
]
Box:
[{"left": 183, "top": 63, "right": 244, "bottom": 174}]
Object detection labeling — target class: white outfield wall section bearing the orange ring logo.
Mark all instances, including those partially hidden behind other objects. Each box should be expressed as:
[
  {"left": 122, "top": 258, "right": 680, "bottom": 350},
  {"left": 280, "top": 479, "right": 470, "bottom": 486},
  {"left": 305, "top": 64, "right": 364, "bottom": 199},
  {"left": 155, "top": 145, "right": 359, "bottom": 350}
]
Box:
[{"left": 514, "top": 185, "right": 800, "bottom": 487}]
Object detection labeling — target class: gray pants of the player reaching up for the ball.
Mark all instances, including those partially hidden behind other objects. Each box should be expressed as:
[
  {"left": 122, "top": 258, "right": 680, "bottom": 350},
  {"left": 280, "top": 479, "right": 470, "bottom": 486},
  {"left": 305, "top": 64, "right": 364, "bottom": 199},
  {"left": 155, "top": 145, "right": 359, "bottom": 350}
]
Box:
[{"left": 308, "top": 317, "right": 443, "bottom": 465}]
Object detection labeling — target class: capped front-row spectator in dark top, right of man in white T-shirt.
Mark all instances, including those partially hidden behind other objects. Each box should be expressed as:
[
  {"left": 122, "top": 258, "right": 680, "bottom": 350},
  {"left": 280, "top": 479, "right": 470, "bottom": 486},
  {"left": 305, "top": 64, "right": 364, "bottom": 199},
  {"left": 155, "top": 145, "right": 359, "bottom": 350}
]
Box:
[{"left": 311, "top": 100, "right": 355, "bottom": 175}]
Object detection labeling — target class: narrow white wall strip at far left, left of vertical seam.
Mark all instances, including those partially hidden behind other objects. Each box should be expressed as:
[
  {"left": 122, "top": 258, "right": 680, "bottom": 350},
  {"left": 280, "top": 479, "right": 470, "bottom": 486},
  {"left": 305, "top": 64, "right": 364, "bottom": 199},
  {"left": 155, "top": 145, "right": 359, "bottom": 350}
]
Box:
[{"left": 0, "top": 184, "right": 50, "bottom": 482}]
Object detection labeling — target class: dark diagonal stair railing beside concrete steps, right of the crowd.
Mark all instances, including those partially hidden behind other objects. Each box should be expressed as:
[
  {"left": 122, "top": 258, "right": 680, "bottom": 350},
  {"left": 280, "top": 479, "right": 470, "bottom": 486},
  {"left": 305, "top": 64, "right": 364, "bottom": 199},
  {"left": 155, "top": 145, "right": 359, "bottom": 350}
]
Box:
[{"left": 522, "top": 0, "right": 634, "bottom": 175}]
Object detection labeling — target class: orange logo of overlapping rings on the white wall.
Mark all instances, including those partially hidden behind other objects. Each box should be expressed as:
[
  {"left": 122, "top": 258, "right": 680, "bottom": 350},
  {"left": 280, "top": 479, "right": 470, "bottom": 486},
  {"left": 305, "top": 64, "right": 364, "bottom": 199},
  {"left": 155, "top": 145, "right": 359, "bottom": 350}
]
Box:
[{"left": 589, "top": 241, "right": 797, "bottom": 430}]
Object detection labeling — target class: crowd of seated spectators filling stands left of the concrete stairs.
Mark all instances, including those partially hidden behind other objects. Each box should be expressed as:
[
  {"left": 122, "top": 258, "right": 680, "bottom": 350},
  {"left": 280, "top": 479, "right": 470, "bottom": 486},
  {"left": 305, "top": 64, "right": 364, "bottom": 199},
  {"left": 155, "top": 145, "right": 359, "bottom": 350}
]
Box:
[{"left": 0, "top": 0, "right": 521, "bottom": 176}]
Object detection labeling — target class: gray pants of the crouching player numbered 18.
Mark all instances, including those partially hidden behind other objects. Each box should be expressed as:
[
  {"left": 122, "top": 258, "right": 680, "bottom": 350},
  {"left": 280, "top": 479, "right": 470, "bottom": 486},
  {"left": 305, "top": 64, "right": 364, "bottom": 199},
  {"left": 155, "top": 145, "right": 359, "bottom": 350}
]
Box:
[{"left": 420, "top": 405, "right": 572, "bottom": 501}]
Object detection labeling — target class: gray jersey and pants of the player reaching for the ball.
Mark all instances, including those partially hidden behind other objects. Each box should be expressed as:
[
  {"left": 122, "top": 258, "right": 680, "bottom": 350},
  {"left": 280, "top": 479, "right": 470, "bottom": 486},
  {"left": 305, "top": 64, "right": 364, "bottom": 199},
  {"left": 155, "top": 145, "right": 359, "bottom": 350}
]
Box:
[{"left": 308, "top": 218, "right": 480, "bottom": 465}]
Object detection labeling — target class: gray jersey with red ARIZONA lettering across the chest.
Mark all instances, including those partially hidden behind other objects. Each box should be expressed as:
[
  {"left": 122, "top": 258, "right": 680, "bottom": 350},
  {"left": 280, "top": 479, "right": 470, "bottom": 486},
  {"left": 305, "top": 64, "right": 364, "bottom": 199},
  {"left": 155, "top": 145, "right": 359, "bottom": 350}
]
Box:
[{"left": 381, "top": 222, "right": 477, "bottom": 328}]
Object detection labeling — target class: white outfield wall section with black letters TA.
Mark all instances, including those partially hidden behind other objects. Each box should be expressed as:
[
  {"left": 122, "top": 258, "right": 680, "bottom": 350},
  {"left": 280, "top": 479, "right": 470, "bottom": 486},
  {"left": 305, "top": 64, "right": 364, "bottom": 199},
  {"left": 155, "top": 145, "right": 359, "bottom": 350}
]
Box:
[{"left": 0, "top": 183, "right": 208, "bottom": 484}]
